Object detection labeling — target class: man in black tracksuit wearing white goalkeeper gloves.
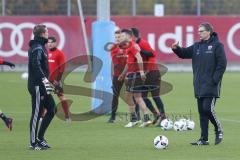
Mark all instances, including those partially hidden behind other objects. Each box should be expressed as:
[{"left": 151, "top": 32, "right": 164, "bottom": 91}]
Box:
[{"left": 28, "top": 25, "right": 55, "bottom": 150}]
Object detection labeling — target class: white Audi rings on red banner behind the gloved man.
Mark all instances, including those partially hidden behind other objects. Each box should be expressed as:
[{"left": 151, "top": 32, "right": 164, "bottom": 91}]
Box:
[{"left": 0, "top": 22, "right": 65, "bottom": 57}]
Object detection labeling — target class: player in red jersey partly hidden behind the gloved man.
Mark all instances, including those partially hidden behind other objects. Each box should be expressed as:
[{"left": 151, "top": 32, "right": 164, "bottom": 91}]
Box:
[{"left": 48, "top": 36, "right": 71, "bottom": 122}]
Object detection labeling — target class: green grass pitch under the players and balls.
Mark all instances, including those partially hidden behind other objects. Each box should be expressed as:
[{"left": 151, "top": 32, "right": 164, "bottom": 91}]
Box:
[{"left": 0, "top": 72, "right": 240, "bottom": 160}]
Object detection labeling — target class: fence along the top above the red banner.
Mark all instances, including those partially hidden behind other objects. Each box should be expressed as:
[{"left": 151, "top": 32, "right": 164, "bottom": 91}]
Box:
[{"left": 0, "top": 0, "right": 240, "bottom": 16}]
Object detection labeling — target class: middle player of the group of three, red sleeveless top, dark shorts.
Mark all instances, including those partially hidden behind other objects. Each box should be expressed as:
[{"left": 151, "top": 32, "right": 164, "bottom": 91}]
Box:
[{"left": 119, "top": 29, "right": 152, "bottom": 128}]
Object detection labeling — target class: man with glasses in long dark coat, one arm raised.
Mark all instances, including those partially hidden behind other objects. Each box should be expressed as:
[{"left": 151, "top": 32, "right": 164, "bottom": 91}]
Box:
[{"left": 172, "top": 23, "right": 227, "bottom": 145}]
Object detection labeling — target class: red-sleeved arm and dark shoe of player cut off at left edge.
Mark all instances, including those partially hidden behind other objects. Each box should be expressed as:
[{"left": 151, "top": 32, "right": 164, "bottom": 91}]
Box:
[{"left": 0, "top": 58, "right": 15, "bottom": 131}]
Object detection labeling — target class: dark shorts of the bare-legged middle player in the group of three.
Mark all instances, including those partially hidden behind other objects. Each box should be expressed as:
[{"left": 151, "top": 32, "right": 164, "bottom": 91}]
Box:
[{"left": 125, "top": 72, "right": 144, "bottom": 93}]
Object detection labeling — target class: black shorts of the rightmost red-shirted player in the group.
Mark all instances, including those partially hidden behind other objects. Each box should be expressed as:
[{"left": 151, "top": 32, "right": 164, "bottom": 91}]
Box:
[{"left": 142, "top": 70, "right": 161, "bottom": 97}]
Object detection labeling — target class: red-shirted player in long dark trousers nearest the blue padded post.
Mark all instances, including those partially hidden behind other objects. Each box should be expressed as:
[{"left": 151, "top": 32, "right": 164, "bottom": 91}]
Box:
[{"left": 108, "top": 30, "right": 127, "bottom": 123}]
